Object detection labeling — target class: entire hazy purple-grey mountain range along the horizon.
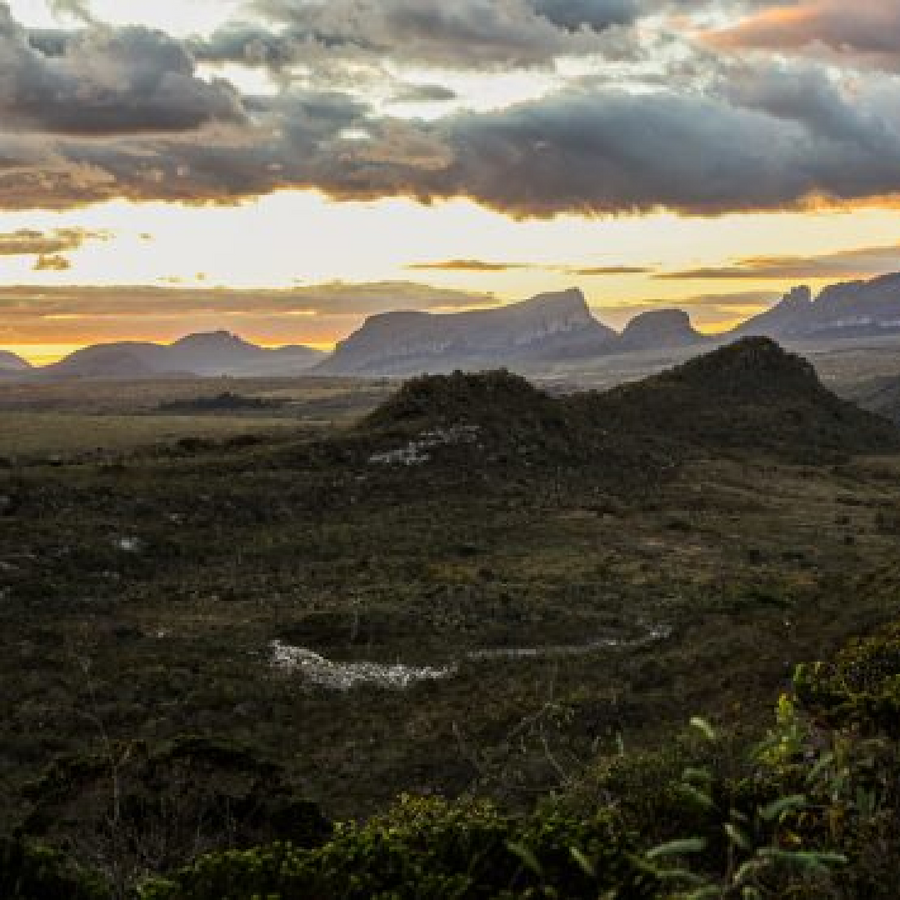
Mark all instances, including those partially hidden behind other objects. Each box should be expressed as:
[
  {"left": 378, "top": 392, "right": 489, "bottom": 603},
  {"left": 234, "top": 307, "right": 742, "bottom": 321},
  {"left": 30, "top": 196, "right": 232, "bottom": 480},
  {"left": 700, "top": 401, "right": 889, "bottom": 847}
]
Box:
[{"left": 0, "top": 273, "right": 900, "bottom": 381}]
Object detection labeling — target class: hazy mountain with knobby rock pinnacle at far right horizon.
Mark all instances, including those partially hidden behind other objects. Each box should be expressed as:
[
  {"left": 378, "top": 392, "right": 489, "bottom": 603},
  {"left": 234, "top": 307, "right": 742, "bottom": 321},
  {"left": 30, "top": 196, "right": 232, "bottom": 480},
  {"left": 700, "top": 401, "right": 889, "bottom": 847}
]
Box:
[{"left": 734, "top": 273, "right": 900, "bottom": 340}]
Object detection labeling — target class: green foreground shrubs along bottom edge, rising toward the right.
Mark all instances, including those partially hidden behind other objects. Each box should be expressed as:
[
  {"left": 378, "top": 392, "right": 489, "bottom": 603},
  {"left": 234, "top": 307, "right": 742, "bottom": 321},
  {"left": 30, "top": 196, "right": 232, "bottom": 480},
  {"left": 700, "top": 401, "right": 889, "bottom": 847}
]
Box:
[{"left": 10, "top": 625, "right": 900, "bottom": 900}]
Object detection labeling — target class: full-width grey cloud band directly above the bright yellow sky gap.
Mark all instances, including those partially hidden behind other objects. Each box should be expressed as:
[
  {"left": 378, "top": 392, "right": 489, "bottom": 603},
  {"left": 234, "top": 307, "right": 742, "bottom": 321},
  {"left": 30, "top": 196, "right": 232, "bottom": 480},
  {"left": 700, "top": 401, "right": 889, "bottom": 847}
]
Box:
[{"left": 0, "top": 74, "right": 900, "bottom": 216}]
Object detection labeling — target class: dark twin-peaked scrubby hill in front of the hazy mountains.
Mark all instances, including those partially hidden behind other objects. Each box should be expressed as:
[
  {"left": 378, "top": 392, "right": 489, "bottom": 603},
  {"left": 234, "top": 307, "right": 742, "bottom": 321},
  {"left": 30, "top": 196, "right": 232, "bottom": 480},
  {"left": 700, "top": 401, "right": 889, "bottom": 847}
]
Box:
[{"left": 361, "top": 338, "right": 900, "bottom": 472}]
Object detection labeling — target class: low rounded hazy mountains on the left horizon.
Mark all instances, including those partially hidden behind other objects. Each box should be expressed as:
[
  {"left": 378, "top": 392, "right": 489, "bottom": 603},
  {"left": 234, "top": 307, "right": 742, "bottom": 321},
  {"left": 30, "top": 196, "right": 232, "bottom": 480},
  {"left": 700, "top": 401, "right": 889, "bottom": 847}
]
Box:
[{"left": 32, "top": 331, "right": 324, "bottom": 381}]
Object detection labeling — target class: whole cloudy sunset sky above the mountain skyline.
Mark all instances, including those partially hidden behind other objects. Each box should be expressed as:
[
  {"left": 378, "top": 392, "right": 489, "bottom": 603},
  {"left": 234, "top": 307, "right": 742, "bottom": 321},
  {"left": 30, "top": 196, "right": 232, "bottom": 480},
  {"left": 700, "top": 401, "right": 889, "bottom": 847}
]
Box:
[{"left": 0, "top": 0, "right": 900, "bottom": 361}]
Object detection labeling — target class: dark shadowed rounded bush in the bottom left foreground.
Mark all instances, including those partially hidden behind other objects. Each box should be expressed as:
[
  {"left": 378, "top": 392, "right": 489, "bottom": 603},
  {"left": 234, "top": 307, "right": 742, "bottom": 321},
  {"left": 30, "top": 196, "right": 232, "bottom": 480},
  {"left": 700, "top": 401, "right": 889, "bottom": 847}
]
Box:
[{"left": 23, "top": 737, "right": 331, "bottom": 895}]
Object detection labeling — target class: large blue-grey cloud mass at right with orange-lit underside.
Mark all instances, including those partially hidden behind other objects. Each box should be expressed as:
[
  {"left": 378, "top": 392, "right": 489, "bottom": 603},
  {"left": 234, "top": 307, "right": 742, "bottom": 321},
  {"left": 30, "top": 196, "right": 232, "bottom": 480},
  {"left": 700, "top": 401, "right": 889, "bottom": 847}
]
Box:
[{"left": 344, "top": 82, "right": 900, "bottom": 216}]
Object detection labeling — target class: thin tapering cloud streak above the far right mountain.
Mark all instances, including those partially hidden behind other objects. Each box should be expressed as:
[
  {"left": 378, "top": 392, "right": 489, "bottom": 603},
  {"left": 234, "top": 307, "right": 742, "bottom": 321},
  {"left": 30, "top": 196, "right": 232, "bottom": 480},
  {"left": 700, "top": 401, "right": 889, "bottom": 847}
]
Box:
[{"left": 655, "top": 244, "right": 900, "bottom": 281}]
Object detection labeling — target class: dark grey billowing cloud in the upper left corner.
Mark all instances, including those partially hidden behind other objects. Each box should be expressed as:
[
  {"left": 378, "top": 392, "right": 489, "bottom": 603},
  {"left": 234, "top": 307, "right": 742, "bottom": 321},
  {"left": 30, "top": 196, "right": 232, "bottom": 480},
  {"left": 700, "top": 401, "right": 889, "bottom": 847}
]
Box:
[{"left": 0, "top": 3, "right": 244, "bottom": 136}]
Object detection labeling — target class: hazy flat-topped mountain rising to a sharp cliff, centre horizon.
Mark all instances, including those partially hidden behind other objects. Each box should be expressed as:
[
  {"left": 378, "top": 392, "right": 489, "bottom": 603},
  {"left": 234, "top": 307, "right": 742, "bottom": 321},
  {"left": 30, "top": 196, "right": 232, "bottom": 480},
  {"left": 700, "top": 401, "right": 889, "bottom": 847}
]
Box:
[{"left": 317, "top": 289, "right": 617, "bottom": 375}]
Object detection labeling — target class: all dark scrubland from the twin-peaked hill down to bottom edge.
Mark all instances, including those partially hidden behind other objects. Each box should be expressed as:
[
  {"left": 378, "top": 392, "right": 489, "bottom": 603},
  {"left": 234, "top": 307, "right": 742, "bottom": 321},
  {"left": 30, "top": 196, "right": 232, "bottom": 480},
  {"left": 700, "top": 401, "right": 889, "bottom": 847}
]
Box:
[{"left": 0, "top": 339, "right": 900, "bottom": 900}]
